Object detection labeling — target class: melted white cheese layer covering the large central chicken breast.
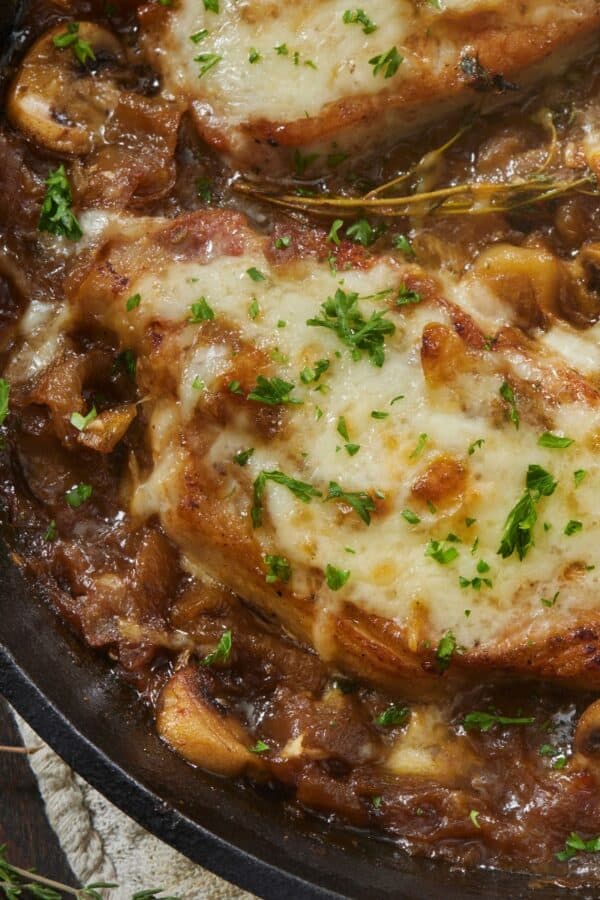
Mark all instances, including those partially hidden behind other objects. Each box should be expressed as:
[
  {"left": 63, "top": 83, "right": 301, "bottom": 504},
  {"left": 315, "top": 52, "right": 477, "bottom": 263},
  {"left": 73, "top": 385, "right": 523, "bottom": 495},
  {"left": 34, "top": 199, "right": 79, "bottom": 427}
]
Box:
[{"left": 74, "top": 211, "right": 600, "bottom": 672}]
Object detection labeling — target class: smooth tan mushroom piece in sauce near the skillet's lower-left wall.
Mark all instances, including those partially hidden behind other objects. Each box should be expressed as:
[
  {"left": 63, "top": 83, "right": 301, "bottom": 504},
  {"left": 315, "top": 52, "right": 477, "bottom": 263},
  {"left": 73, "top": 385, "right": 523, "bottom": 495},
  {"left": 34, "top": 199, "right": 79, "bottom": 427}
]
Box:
[{"left": 156, "top": 666, "right": 261, "bottom": 777}]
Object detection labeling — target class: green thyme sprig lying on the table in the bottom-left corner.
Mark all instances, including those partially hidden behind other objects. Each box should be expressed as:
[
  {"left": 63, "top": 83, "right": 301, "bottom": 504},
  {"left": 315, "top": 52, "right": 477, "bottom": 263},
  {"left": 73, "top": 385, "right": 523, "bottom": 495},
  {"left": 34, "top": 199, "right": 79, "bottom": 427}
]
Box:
[{"left": 0, "top": 844, "right": 179, "bottom": 900}]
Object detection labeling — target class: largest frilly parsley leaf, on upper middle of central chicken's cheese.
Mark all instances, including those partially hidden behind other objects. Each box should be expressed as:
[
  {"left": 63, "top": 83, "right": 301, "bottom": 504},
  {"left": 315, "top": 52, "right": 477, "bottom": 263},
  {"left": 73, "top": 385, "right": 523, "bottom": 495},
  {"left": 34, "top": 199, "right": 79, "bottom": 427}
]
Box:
[{"left": 306, "top": 288, "right": 396, "bottom": 366}]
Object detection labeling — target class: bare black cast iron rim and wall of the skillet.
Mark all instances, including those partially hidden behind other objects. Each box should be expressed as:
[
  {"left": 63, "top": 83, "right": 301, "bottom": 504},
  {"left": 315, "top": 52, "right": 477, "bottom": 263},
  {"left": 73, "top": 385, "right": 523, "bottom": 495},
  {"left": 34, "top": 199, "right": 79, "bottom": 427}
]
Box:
[{"left": 0, "top": 8, "right": 593, "bottom": 900}]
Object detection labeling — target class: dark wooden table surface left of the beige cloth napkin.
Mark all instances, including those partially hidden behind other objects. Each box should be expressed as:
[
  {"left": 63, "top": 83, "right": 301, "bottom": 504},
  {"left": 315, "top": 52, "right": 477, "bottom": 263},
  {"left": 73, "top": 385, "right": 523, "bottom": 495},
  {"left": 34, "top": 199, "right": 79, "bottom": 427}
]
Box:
[{"left": 0, "top": 697, "right": 77, "bottom": 885}]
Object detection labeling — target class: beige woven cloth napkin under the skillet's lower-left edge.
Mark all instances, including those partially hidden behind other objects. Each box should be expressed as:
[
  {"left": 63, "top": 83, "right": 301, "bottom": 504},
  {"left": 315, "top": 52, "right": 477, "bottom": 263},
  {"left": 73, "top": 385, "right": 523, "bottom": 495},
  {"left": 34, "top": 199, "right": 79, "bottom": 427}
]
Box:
[{"left": 13, "top": 713, "right": 253, "bottom": 900}]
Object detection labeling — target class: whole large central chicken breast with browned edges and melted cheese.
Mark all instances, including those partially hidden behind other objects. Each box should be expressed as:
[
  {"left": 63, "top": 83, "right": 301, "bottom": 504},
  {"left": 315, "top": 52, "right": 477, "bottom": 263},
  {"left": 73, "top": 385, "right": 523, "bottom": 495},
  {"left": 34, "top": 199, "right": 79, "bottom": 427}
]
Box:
[{"left": 62, "top": 211, "right": 600, "bottom": 690}]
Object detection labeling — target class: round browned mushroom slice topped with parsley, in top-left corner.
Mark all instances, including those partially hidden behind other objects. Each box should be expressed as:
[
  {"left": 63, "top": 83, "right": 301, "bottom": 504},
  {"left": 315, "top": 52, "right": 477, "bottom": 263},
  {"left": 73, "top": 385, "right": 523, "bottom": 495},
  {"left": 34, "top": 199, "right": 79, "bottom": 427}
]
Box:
[{"left": 7, "top": 22, "right": 125, "bottom": 156}]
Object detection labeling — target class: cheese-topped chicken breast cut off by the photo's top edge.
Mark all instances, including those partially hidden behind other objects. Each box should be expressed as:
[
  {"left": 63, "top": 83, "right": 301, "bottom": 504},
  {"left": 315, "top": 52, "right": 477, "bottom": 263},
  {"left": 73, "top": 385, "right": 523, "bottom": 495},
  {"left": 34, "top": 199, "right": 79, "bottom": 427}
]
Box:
[{"left": 142, "top": 0, "right": 600, "bottom": 175}]
